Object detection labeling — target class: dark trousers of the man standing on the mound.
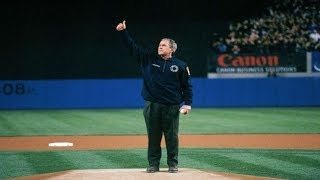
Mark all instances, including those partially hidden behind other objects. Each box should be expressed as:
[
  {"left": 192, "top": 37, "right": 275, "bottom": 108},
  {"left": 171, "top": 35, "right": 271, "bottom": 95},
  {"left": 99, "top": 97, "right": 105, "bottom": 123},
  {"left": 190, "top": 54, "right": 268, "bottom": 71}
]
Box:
[{"left": 143, "top": 101, "right": 180, "bottom": 166}]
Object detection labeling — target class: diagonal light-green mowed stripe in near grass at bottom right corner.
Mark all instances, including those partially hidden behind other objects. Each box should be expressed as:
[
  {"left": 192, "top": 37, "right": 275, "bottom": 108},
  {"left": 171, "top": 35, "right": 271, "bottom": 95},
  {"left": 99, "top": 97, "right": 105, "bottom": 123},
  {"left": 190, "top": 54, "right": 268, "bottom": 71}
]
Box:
[{"left": 223, "top": 152, "right": 320, "bottom": 179}]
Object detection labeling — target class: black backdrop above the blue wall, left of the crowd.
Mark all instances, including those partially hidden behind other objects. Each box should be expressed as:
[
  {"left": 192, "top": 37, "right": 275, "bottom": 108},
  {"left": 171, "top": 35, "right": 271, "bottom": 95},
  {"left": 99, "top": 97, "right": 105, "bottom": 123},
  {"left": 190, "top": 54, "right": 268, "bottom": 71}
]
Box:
[{"left": 0, "top": 0, "right": 272, "bottom": 80}]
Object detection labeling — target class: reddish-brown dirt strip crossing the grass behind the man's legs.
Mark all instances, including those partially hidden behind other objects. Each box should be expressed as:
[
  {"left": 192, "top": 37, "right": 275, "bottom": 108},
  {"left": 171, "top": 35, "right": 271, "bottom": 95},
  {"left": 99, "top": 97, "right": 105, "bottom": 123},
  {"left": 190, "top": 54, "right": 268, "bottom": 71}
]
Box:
[{"left": 0, "top": 134, "right": 320, "bottom": 150}]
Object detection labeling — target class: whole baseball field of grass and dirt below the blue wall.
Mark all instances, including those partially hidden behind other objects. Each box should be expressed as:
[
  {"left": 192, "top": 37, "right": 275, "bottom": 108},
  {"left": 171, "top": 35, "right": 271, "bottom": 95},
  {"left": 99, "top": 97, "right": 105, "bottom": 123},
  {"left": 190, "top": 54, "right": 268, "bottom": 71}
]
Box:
[{"left": 0, "top": 107, "right": 320, "bottom": 179}]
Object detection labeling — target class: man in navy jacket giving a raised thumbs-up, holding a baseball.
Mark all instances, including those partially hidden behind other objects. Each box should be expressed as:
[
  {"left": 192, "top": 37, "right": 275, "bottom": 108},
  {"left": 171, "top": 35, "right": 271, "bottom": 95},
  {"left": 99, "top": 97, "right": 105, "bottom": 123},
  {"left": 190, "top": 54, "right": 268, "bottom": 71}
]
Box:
[{"left": 116, "top": 21, "right": 192, "bottom": 173}]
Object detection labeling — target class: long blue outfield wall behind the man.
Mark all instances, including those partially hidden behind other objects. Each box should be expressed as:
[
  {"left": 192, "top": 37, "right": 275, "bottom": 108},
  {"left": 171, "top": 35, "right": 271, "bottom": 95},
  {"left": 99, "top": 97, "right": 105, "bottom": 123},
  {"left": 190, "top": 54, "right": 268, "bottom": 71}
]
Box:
[{"left": 0, "top": 77, "right": 320, "bottom": 109}]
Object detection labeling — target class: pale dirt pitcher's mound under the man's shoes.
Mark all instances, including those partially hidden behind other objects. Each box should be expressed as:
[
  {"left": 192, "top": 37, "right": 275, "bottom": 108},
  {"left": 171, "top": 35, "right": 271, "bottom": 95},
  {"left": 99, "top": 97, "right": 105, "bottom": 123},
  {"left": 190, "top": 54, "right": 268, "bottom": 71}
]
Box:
[{"left": 16, "top": 168, "right": 280, "bottom": 180}]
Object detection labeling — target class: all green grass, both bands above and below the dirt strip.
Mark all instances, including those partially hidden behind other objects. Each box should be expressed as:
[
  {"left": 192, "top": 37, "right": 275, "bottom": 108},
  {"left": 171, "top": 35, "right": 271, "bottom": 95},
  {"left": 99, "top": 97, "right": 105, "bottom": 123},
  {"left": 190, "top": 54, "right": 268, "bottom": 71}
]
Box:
[{"left": 0, "top": 107, "right": 320, "bottom": 179}]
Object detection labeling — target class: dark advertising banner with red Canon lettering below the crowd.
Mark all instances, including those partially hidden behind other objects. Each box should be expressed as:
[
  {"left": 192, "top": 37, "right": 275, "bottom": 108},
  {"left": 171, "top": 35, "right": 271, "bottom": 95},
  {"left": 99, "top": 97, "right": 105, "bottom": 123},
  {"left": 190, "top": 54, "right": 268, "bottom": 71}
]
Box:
[{"left": 208, "top": 53, "right": 307, "bottom": 74}]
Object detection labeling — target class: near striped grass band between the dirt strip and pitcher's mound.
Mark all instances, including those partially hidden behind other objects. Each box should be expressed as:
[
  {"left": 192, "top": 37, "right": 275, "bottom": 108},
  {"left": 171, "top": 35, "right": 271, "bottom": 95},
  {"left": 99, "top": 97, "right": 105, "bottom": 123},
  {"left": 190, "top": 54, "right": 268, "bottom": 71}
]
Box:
[{"left": 0, "top": 148, "right": 320, "bottom": 179}]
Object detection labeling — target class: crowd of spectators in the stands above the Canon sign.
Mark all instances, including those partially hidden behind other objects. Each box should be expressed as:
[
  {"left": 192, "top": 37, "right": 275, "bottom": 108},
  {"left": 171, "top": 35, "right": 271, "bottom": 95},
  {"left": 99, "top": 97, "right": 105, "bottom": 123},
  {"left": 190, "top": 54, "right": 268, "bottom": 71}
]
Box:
[{"left": 212, "top": 0, "right": 320, "bottom": 54}]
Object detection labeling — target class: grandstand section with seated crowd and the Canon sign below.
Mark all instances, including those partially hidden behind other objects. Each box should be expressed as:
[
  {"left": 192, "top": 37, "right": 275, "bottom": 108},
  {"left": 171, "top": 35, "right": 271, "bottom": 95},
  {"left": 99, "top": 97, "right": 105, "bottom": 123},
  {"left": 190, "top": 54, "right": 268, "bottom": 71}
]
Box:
[{"left": 208, "top": 0, "right": 320, "bottom": 77}]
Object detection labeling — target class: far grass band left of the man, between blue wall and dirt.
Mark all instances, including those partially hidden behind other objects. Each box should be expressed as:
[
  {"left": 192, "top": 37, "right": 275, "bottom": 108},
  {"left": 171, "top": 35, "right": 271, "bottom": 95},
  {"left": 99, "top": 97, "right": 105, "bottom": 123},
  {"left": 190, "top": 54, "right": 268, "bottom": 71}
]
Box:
[{"left": 0, "top": 110, "right": 146, "bottom": 136}]
